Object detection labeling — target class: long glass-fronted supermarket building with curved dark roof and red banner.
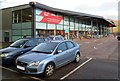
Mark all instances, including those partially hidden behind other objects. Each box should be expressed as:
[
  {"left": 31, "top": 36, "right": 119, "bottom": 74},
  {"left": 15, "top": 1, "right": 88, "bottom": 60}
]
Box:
[{"left": 0, "top": 2, "right": 115, "bottom": 42}]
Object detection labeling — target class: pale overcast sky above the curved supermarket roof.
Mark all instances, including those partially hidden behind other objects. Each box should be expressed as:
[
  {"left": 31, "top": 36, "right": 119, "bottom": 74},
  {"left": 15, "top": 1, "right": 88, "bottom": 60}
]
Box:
[{"left": 0, "top": 0, "right": 119, "bottom": 20}]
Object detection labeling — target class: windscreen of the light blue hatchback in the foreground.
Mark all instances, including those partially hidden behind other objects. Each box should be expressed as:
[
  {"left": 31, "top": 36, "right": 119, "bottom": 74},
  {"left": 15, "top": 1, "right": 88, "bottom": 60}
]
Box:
[{"left": 32, "top": 42, "right": 58, "bottom": 54}]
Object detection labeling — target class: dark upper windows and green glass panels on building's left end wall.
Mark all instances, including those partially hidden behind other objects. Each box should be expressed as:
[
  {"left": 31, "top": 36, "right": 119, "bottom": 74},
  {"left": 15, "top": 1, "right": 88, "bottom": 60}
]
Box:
[{"left": 12, "top": 8, "right": 32, "bottom": 41}]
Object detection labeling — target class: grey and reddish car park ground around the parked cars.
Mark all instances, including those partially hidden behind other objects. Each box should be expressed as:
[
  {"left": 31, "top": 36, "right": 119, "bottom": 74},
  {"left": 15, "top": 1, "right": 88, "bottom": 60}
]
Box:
[{"left": 0, "top": 37, "right": 120, "bottom": 81}]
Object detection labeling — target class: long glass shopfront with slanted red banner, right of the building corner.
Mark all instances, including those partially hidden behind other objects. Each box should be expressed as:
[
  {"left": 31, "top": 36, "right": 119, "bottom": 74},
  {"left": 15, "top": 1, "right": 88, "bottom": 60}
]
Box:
[{"left": 35, "top": 9, "right": 101, "bottom": 36}]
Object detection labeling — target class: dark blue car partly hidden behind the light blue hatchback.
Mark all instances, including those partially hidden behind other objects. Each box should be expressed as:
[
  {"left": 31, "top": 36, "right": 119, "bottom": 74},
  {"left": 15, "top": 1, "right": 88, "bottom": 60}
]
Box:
[{"left": 0, "top": 38, "right": 46, "bottom": 64}]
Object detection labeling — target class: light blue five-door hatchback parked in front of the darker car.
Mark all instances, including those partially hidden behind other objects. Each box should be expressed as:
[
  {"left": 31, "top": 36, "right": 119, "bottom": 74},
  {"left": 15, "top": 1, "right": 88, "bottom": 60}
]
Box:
[{"left": 16, "top": 41, "right": 80, "bottom": 77}]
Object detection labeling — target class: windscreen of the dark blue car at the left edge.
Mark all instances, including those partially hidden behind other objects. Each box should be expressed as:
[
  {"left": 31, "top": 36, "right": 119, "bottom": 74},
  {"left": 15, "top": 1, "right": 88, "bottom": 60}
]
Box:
[{"left": 10, "top": 39, "right": 29, "bottom": 48}]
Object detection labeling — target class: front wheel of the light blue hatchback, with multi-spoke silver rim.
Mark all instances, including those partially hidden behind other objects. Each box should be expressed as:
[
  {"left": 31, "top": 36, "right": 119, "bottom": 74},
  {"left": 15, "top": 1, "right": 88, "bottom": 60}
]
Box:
[{"left": 44, "top": 63, "right": 55, "bottom": 77}]
